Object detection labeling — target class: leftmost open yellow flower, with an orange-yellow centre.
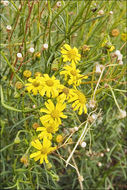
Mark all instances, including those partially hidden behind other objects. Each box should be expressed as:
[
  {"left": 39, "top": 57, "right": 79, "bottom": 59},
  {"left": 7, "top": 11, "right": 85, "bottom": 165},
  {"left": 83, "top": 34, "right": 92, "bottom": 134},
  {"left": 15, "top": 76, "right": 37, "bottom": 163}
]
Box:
[{"left": 25, "top": 76, "right": 43, "bottom": 95}]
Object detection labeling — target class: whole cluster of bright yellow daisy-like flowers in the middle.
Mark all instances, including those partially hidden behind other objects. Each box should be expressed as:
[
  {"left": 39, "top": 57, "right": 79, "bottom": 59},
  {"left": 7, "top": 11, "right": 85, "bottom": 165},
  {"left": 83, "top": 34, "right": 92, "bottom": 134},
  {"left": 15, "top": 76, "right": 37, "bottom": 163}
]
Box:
[{"left": 24, "top": 44, "right": 87, "bottom": 164}]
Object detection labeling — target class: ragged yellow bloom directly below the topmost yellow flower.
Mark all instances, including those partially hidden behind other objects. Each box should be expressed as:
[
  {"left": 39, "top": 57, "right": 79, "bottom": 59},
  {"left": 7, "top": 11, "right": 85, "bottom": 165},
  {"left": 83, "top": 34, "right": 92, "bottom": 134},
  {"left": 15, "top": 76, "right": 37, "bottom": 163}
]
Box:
[{"left": 60, "top": 63, "right": 88, "bottom": 86}]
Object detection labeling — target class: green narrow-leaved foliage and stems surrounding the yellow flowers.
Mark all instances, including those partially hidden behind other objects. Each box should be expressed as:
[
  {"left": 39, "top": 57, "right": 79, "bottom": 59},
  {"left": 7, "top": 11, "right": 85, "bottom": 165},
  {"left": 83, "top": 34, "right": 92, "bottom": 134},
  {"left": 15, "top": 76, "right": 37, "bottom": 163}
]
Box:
[{"left": 0, "top": 0, "right": 127, "bottom": 190}]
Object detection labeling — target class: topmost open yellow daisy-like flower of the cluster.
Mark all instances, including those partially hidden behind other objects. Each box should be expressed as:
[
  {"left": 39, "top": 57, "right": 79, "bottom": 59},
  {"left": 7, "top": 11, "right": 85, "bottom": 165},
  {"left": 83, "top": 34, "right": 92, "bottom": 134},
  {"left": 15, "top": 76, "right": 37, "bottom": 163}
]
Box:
[{"left": 61, "top": 44, "right": 81, "bottom": 63}]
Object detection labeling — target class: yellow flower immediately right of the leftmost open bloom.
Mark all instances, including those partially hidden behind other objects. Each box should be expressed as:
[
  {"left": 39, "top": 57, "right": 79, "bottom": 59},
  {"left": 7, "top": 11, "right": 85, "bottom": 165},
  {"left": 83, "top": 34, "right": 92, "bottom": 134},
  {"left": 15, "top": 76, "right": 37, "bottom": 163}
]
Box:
[{"left": 40, "top": 74, "right": 60, "bottom": 98}]
